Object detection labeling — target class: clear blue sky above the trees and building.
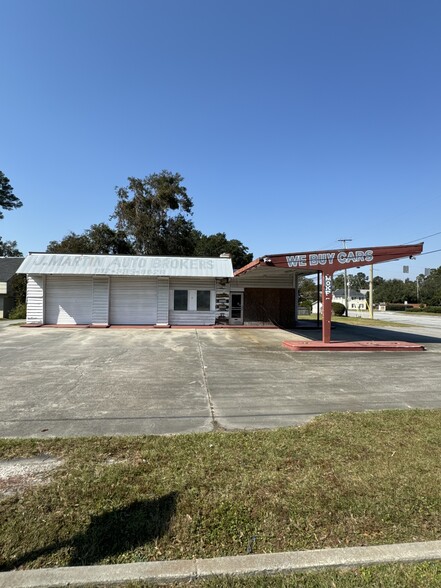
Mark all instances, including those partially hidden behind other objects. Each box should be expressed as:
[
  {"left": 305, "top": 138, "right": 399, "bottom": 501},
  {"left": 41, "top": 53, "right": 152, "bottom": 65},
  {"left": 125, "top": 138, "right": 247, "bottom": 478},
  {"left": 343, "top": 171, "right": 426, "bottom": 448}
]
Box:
[{"left": 0, "top": 0, "right": 441, "bottom": 278}]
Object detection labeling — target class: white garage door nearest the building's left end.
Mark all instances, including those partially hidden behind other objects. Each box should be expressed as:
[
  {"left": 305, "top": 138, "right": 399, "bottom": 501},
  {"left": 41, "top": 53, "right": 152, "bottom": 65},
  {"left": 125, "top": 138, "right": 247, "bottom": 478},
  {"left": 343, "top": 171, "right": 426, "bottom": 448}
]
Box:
[{"left": 45, "top": 276, "right": 93, "bottom": 325}]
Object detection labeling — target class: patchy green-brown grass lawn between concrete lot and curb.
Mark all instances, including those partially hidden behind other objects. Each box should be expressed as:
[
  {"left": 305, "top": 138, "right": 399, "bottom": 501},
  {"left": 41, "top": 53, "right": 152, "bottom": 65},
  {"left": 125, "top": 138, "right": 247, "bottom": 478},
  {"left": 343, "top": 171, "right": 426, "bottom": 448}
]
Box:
[{"left": 0, "top": 410, "right": 441, "bottom": 586}]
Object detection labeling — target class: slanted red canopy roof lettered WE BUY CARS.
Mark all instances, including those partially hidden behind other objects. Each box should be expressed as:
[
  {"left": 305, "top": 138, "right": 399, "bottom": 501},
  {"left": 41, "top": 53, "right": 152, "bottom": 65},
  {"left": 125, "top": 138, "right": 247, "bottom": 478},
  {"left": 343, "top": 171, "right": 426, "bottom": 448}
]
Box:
[{"left": 234, "top": 243, "right": 423, "bottom": 277}]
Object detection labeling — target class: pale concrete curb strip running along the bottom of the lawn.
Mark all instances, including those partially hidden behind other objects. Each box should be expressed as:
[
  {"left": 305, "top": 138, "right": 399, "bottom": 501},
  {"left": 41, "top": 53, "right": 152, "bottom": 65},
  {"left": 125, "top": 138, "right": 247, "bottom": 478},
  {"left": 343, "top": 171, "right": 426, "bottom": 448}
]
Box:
[{"left": 0, "top": 541, "right": 441, "bottom": 588}]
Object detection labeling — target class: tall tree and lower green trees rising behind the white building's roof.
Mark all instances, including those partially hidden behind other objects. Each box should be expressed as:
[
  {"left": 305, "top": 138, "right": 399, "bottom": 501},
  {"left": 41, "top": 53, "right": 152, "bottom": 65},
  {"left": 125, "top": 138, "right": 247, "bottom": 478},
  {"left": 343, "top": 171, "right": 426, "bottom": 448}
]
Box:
[{"left": 47, "top": 170, "right": 253, "bottom": 268}]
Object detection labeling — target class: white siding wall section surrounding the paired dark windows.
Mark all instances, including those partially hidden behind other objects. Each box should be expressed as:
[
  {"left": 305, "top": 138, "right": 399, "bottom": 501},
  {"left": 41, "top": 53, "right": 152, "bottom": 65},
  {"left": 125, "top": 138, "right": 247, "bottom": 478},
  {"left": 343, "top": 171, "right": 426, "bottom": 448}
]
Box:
[{"left": 169, "top": 278, "right": 216, "bottom": 325}]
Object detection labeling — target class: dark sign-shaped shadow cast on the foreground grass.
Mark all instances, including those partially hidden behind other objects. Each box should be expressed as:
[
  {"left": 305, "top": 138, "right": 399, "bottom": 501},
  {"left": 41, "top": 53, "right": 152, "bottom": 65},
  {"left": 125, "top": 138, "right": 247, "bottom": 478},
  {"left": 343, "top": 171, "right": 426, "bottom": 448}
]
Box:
[{"left": 0, "top": 492, "right": 178, "bottom": 571}]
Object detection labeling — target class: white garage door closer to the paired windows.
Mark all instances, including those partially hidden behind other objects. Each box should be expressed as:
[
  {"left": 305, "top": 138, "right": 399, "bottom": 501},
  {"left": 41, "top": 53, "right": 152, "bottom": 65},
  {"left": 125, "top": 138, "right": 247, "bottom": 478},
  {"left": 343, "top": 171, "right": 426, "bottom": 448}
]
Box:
[{"left": 110, "top": 278, "right": 157, "bottom": 325}]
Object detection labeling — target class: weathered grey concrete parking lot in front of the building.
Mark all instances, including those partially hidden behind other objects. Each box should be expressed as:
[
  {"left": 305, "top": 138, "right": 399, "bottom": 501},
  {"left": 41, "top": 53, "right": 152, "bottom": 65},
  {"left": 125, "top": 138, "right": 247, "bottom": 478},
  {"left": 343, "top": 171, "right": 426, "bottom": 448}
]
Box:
[{"left": 0, "top": 323, "right": 441, "bottom": 437}]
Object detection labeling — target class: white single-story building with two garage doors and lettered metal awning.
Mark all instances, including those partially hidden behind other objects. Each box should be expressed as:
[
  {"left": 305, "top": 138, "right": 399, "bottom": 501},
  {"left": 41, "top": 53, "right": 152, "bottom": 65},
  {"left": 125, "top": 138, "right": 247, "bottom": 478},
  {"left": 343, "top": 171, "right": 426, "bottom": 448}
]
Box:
[{"left": 18, "top": 253, "right": 294, "bottom": 327}]
